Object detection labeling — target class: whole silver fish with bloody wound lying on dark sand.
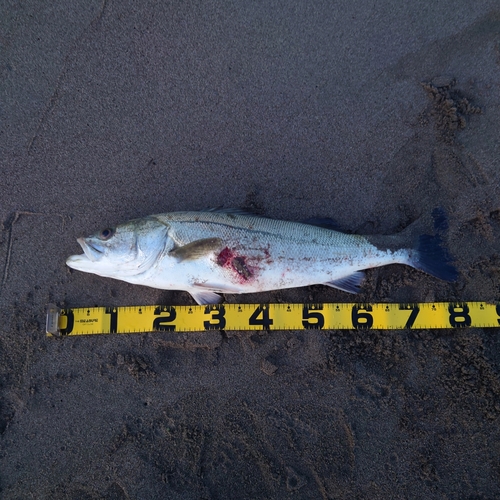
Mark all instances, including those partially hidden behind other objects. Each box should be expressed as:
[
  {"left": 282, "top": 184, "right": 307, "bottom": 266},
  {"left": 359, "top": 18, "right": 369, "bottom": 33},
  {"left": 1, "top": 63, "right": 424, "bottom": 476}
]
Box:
[{"left": 66, "top": 209, "right": 458, "bottom": 304}]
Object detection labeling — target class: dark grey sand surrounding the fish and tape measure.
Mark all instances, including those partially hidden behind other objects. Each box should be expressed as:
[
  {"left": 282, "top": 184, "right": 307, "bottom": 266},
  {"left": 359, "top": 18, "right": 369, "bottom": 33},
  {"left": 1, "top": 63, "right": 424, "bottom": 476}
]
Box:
[{"left": 0, "top": 0, "right": 500, "bottom": 500}]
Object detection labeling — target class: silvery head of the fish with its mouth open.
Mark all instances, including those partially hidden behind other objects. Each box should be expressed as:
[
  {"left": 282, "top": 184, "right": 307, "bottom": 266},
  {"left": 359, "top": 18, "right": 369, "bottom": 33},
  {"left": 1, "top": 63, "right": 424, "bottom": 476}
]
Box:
[{"left": 66, "top": 217, "right": 169, "bottom": 279}]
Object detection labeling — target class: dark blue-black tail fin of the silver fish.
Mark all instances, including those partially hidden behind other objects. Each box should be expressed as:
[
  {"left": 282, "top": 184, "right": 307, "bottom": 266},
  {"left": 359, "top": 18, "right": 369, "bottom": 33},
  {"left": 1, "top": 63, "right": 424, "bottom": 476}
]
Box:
[{"left": 409, "top": 208, "right": 458, "bottom": 281}]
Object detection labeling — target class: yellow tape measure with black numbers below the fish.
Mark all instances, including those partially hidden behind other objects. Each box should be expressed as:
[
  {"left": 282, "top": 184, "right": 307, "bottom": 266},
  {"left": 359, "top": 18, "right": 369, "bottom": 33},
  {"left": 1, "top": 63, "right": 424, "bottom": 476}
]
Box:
[{"left": 46, "top": 302, "right": 500, "bottom": 336}]
